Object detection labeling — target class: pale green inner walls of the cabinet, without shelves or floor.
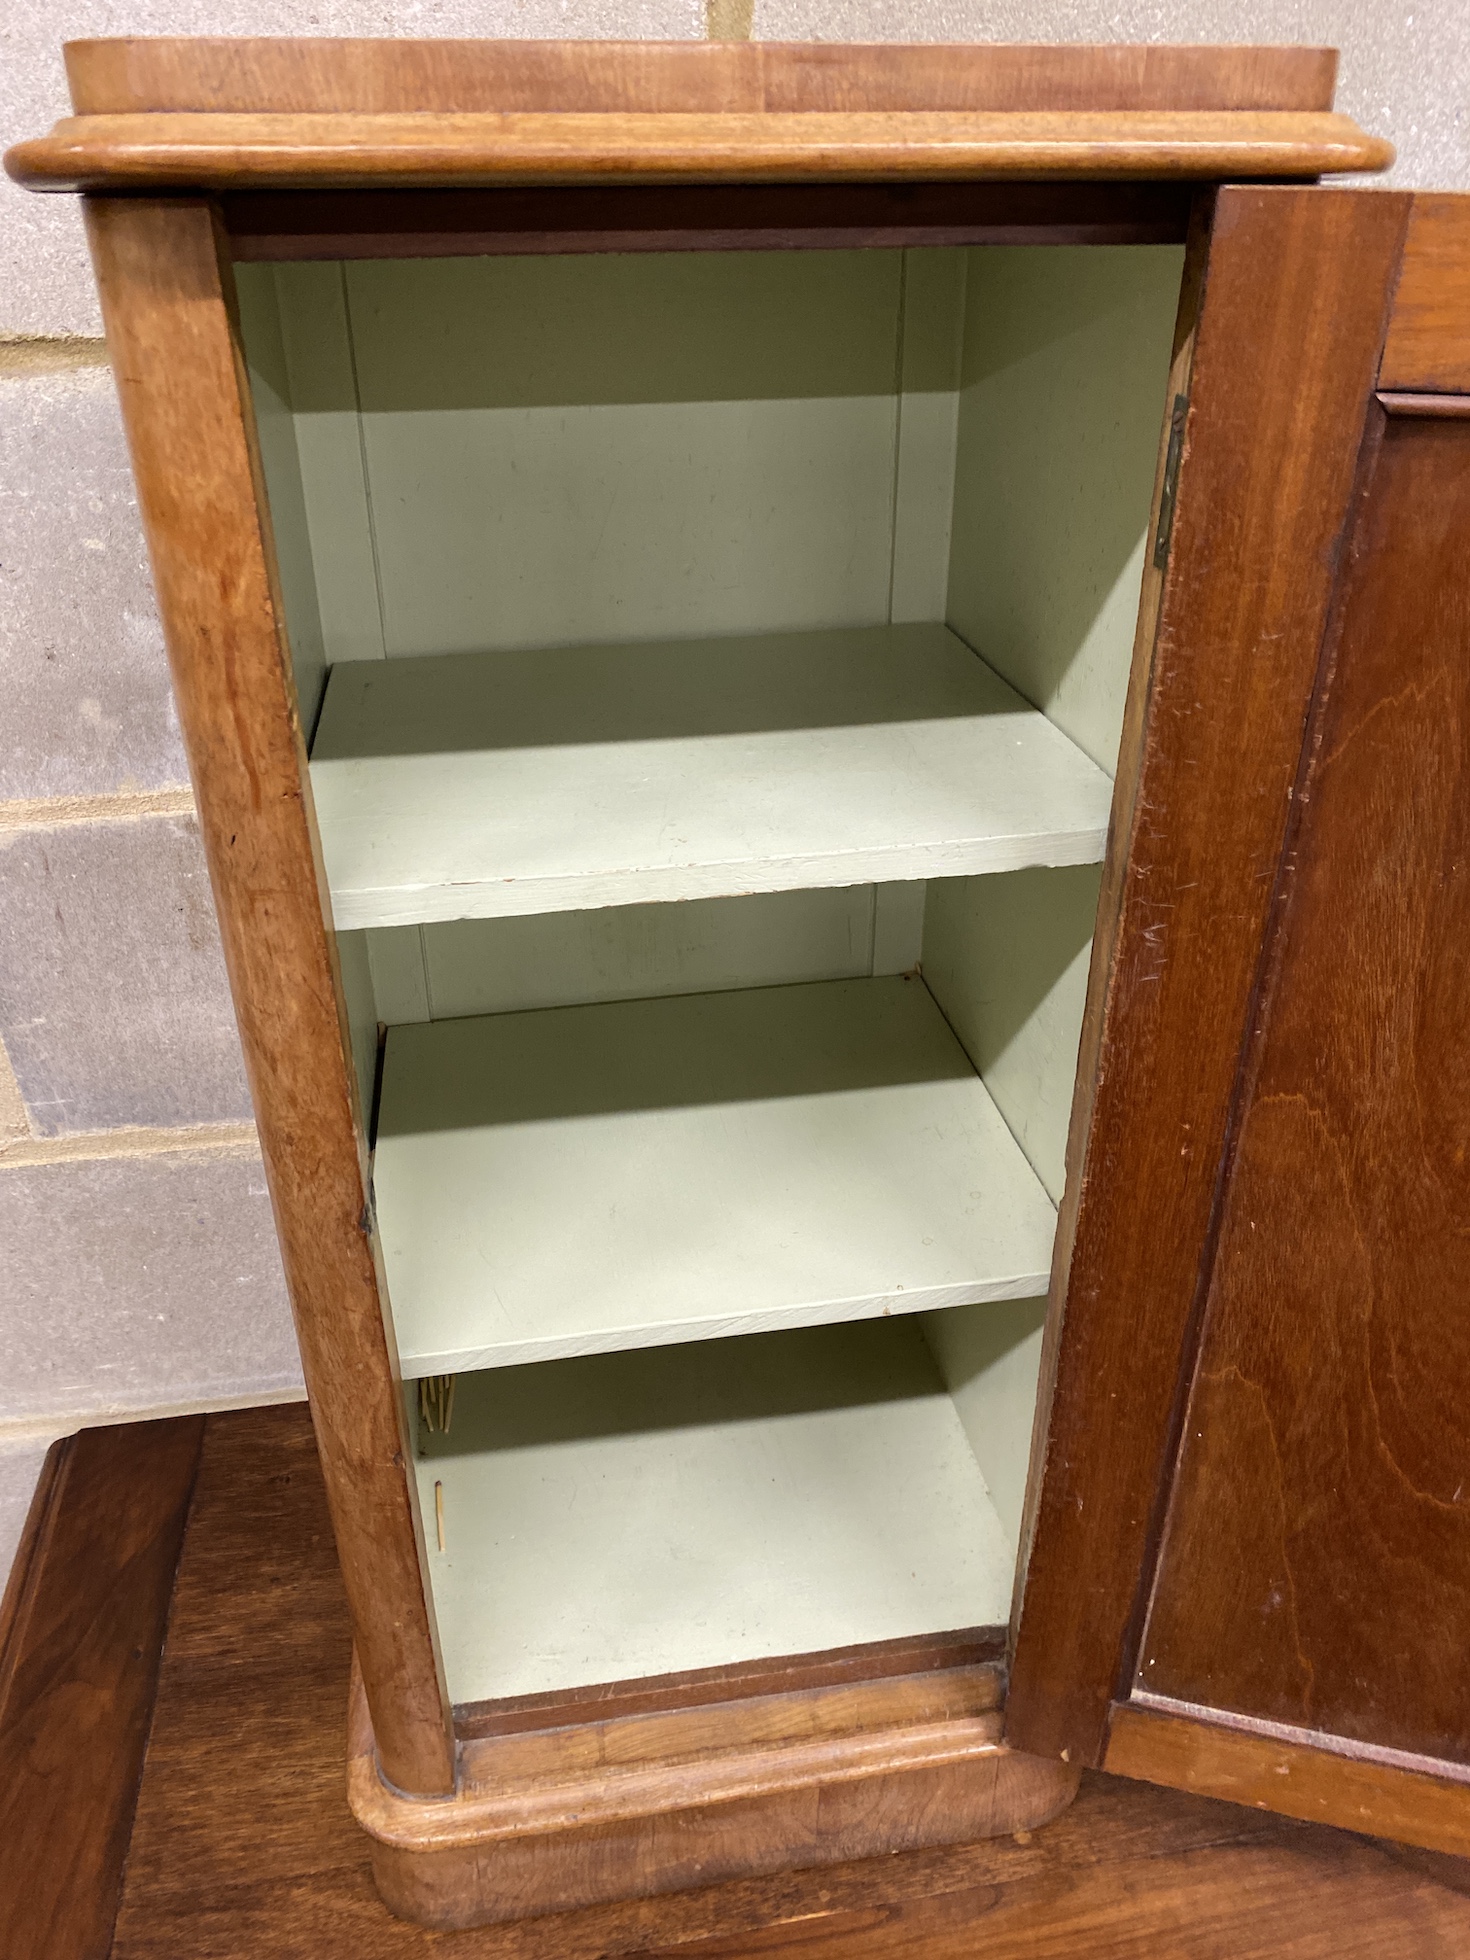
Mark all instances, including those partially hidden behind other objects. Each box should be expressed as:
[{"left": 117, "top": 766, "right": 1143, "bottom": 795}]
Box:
[{"left": 241, "top": 247, "right": 1182, "bottom": 1591}]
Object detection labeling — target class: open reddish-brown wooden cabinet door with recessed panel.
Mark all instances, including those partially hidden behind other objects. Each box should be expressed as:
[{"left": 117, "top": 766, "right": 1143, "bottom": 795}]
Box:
[{"left": 1007, "top": 176, "right": 1470, "bottom": 1850}]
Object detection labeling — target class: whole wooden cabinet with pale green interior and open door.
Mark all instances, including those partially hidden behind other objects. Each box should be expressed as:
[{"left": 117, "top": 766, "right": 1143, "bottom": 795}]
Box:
[{"left": 8, "top": 41, "right": 1470, "bottom": 1927}]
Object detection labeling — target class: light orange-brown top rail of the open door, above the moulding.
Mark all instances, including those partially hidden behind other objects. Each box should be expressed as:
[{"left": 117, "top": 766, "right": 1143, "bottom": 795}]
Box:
[{"left": 1378, "top": 192, "right": 1470, "bottom": 392}]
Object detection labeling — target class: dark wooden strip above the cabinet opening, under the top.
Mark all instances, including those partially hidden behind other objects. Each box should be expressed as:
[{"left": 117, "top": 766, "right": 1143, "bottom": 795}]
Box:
[{"left": 221, "top": 180, "right": 1190, "bottom": 261}]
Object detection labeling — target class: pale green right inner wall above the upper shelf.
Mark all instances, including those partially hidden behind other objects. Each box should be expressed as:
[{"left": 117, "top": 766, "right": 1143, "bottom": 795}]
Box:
[{"left": 947, "top": 245, "right": 1184, "bottom": 774}]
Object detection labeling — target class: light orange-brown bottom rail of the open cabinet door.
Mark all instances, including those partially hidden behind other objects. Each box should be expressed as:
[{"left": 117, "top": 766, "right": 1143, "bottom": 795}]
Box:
[{"left": 1107, "top": 1701, "right": 1470, "bottom": 1858}]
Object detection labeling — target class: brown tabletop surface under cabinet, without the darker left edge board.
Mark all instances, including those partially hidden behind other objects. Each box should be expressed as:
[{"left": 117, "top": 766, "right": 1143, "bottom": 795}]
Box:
[{"left": 112, "top": 1407, "right": 1470, "bottom": 1960}]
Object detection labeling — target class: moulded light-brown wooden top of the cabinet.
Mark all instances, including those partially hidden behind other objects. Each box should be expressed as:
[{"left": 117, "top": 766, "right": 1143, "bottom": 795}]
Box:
[{"left": 6, "top": 39, "right": 1394, "bottom": 190}]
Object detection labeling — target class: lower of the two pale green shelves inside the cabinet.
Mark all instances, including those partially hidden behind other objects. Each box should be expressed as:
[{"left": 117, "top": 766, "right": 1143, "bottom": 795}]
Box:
[{"left": 374, "top": 978, "right": 1054, "bottom": 1376}]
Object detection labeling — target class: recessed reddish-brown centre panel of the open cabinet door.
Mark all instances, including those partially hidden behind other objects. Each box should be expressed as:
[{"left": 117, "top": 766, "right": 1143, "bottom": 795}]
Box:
[{"left": 1139, "top": 417, "right": 1470, "bottom": 1764}]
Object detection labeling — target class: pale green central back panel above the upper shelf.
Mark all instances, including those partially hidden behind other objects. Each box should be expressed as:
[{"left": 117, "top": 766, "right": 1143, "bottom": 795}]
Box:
[{"left": 305, "top": 251, "right": 921, "bottom": 655}]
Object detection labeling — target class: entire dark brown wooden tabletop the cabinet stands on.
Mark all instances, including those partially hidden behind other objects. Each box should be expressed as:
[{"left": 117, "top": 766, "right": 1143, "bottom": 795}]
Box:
[{"left": 0, "top": 1407, "right": 1470, "bottom": 1960}]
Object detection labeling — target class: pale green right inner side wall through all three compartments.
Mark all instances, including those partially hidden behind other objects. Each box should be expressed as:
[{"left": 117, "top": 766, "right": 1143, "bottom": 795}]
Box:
[{"left": 923, "top": 245, "right": 1184, "bottom": 1535}]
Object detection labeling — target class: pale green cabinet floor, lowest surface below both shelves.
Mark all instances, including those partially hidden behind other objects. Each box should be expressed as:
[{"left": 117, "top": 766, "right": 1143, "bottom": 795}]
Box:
[{"left": 417, "top": 1321, "right": 1015, "bottom": 1703}]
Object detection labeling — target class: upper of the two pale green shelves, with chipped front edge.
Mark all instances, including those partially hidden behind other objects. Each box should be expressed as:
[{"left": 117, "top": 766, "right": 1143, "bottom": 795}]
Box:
[{"left": 312, "top": 625, "right": 1111, "bottom": 929}]
